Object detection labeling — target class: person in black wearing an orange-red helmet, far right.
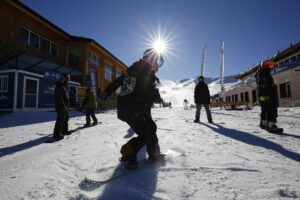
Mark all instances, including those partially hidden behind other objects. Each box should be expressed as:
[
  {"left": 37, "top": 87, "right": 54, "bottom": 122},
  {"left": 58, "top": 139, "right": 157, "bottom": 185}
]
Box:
[{"left": 255, "top": 60, "right": 283, "bottom": 133}]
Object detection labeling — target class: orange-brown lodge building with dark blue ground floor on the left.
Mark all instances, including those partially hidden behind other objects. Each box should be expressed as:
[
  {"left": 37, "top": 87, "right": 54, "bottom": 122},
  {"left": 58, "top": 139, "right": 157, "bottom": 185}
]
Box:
[{"left": 0, "top": 0, "right": 127, "bottom": 111}]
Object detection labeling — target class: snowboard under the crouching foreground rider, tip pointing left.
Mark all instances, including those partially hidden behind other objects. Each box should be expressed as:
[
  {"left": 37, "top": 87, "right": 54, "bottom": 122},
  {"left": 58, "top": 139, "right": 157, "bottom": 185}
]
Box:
[{"left": 79, "top": 149, "right": 186, "bottom": 191}]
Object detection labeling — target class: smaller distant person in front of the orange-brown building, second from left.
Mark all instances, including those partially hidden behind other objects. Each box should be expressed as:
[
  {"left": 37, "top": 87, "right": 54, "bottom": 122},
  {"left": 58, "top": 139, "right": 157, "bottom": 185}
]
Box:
[{"left": 81, "top": 86, "right": 98, "bottom": 126}]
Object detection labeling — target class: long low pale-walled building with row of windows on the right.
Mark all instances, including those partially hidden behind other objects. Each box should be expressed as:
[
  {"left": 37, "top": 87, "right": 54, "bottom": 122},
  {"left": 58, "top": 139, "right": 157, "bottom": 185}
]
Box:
[{"left": 211, "top": 42, "right": 300, "bottom": 108}]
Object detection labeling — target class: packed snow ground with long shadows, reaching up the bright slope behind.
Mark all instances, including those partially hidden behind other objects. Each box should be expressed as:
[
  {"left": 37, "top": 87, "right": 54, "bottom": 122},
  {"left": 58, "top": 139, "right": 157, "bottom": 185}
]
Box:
[{"left": 0, "top": 81, "right": 300, "bottom": 200}]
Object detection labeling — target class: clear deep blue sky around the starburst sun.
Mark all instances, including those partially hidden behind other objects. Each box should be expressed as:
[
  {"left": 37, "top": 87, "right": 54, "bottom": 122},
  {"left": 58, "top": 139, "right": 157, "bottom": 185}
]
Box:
[{"left": 21, "top": 0, "right": 300, "bottom": 80}]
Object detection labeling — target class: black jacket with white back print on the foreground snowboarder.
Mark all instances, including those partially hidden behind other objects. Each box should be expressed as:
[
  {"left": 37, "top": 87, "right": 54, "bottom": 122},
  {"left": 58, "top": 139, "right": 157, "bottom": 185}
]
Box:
[{"left": 105, "top": 59, "right": 161, "bottom": 120}]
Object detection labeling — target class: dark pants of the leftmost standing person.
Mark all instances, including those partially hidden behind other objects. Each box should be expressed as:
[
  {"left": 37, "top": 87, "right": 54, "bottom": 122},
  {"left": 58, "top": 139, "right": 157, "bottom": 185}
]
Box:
[{"left": 53, "top": 110, "right": 69, "bottom": 139}]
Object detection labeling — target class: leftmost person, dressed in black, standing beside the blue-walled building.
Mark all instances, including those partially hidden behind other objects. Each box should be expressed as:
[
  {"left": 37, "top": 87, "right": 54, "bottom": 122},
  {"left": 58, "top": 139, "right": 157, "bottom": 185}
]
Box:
[{"left": 53, "top": 74, "right": 70, "bottom": 141}]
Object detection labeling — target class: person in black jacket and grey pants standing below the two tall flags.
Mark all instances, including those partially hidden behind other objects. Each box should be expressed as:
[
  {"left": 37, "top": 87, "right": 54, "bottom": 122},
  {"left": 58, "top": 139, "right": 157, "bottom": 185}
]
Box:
[{"left": 194, "top": 76, "right": 213, "bottom": 123}]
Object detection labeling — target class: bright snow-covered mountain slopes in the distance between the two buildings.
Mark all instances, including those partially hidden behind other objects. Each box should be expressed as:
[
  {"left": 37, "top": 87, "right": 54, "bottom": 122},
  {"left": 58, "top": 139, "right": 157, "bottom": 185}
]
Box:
[{"left": 158, "top": 75, "right": 239, "bottom": 107}]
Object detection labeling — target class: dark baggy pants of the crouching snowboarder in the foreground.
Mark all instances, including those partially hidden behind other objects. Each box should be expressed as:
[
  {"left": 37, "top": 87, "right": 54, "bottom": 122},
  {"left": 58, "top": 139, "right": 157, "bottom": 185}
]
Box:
[{"left": 120, "top": 110, "right": 160, "bottom": 157}]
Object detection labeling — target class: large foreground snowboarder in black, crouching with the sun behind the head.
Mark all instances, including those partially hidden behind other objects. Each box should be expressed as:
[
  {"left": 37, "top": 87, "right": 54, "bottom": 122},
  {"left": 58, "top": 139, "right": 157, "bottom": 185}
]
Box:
[{"left": 104, "top": 49, "right": 164, "bottom": 168}]
